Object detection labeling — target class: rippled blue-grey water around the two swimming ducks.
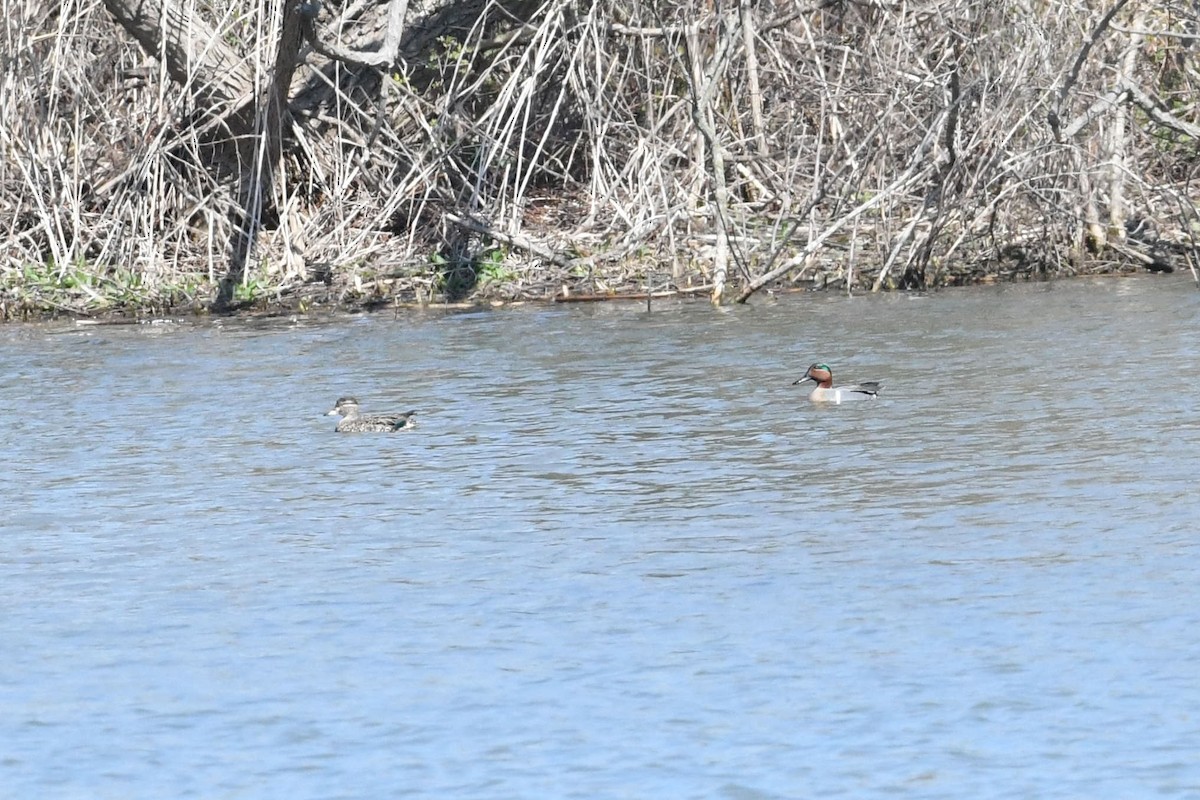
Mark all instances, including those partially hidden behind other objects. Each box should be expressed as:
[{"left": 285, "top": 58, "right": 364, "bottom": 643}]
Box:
[{"left": 0, "top": 276, "right": 1200, "bottom": 800}]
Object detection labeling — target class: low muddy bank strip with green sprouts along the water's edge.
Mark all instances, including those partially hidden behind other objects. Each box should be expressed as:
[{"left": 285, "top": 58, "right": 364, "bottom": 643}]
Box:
[{"left": 0, "top": 248, "right": 1195, "bottom": 324}]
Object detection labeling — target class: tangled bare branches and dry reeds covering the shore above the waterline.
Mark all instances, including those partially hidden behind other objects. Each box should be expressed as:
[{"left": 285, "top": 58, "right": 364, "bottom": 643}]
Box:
[{"left": 0, "top": 0, "right": 1200, "bottom": 315}]
